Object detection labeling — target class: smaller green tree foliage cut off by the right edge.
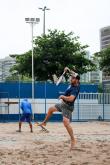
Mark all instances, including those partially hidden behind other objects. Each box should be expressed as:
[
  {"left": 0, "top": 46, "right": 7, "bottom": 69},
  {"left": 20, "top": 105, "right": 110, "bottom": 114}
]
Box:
[{"left": 94, "top": 47, "right": 110, "bottom": 75}]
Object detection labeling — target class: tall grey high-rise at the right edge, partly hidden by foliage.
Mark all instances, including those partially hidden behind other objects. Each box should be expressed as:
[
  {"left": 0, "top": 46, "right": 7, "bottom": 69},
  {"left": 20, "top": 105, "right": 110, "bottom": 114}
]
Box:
[{"left": 100, "top": 26, "right": 110, "bottom": 80}]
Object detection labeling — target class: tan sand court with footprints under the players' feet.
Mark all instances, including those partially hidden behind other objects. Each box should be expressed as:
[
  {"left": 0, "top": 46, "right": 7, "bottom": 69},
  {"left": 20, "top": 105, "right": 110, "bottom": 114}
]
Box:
[{"left": 0, "top": 122, "right": 110, "bottom": 165}]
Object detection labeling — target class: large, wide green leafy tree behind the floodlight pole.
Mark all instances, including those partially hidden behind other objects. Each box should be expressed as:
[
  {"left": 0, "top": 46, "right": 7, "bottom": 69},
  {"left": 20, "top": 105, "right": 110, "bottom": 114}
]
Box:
[{"left": 12, "top": 30, "right": 95, "bottom": 81}]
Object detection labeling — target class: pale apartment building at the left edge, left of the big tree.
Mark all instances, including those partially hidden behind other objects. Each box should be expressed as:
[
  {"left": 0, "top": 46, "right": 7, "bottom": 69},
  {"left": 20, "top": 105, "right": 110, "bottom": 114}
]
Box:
[{"left": 0, "top": 56, "right": 16, "bottom": 82}]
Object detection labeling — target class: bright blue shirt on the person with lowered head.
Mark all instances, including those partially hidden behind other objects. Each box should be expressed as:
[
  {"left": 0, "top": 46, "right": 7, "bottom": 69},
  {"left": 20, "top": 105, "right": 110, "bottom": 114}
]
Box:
[{"left": 20, "top": 99, "right": 32, "bottom": 114}]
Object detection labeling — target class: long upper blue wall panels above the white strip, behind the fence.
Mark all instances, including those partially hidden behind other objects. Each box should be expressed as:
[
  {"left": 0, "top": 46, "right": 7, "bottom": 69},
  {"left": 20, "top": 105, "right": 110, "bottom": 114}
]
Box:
[{"left": 0, "top": 82, "right": 98, "bottom": 99}]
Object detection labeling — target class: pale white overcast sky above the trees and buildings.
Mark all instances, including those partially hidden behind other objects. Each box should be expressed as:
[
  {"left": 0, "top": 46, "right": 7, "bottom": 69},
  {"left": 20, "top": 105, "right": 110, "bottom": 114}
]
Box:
[{"left": 0, "top": 0, "right": 110, "bottom": 59}]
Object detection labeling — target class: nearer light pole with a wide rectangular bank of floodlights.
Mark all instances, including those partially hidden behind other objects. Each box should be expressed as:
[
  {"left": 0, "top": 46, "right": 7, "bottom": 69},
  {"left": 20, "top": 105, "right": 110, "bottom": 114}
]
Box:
[{"left": 25, "top": 18, "right": 40, "bottom": 107}]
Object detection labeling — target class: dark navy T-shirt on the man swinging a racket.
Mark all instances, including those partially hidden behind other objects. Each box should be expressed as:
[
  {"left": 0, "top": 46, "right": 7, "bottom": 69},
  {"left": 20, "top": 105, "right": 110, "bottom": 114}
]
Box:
[{"left": 63, "top": 84, "right": 80, "bottom": 106}]
